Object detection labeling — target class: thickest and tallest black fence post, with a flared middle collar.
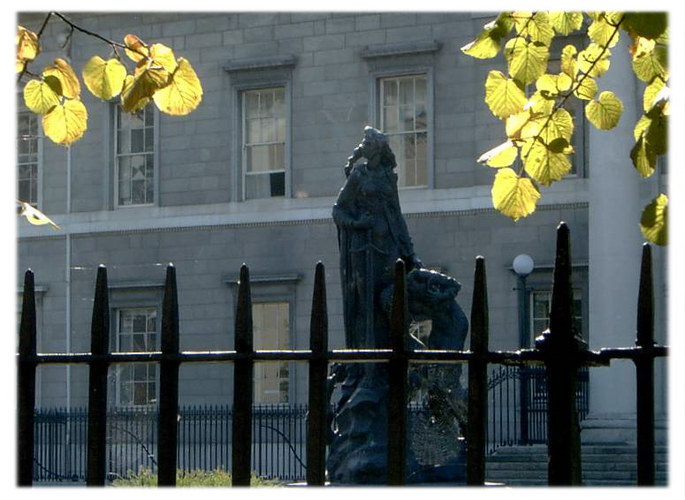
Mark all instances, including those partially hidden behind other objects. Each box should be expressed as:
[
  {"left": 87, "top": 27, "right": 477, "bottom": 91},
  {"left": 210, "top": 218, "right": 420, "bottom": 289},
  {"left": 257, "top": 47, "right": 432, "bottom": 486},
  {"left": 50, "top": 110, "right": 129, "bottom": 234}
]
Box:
[{"left": 535, "top": 222, "right": 584, "bottom": 486}]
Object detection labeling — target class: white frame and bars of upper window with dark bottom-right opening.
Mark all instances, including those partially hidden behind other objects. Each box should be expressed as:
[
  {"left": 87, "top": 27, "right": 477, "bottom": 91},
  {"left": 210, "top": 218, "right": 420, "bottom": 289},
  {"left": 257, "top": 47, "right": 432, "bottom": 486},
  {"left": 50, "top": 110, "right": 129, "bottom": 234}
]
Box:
[{"left": 239, "top": 84, "right": 290, "bottom": 200}]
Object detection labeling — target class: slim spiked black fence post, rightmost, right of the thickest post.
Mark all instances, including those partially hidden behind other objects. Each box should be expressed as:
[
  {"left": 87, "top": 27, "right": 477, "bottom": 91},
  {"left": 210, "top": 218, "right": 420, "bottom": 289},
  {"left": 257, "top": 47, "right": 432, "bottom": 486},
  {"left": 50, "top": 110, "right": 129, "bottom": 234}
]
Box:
[{"left": 635, "top": 243, "right": 655, "bottom": 486}]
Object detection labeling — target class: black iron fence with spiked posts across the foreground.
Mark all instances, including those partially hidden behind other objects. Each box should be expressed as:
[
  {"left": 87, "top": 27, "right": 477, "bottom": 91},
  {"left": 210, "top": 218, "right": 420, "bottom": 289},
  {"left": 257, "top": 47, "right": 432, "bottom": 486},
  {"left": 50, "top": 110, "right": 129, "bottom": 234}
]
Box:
[{"left": 17, "top": 223, "right": 667, "bottom": 486}]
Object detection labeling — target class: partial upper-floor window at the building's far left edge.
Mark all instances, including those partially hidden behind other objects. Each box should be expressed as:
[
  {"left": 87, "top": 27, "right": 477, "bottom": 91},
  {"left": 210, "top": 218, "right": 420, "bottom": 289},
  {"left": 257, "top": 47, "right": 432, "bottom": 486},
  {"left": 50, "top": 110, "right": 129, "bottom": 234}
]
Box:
[{"left": 17, "top": 113, "right": 39, "bottom": 207}]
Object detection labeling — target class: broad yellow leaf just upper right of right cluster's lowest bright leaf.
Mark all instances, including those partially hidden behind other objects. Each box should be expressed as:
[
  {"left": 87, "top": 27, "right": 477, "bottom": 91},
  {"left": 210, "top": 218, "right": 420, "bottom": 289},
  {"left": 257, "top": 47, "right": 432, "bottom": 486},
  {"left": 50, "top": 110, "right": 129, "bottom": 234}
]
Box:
[{"left": 521, "top": 139, "right": 573, "bottom": 186}]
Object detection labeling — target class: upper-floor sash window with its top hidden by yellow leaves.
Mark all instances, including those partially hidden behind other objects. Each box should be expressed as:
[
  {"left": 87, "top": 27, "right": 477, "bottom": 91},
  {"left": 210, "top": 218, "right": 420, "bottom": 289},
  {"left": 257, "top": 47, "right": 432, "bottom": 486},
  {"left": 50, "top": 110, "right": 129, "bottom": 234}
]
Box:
[{"left": 115, "top": 105, "right": 155, "bottom": 206}]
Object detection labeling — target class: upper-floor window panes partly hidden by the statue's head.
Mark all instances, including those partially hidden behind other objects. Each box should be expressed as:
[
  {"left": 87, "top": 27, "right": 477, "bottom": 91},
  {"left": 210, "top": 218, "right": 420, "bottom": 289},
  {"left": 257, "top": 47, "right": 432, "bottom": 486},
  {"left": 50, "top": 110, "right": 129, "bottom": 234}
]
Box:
[{"left": 379, "top": 75, "right": 428, "bottom": 187}]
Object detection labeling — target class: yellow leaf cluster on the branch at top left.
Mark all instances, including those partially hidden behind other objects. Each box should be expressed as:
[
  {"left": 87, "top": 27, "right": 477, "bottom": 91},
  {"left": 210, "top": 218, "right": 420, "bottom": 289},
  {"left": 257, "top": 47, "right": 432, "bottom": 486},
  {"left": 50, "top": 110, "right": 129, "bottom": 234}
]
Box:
[{"left": 15, "top": 15, "right": 202, "bottom": 146}]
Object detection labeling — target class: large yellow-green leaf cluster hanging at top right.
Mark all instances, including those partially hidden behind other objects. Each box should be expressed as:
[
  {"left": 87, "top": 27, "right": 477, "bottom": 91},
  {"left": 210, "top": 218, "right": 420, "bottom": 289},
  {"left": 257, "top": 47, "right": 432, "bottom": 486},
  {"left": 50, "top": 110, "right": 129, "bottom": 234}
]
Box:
[{"left": 461, "top": 11, "right": 669, "bottom": 246}]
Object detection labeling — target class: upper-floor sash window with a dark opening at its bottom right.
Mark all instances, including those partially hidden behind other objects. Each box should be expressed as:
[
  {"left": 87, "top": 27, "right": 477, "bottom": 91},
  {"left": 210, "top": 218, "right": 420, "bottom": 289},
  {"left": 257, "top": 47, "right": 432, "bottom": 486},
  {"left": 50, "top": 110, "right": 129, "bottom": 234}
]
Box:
[{"left": 242, "top": 87, "right": 286, "bottom": 199}]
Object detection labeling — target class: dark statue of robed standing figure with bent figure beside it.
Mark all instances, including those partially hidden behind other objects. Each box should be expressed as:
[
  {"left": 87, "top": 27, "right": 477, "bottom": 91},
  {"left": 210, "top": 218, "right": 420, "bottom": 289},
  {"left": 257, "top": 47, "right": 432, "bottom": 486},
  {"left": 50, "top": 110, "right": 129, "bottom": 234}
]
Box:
[{"left": 327, "top": 127, "right": 468, "bottom": 484}]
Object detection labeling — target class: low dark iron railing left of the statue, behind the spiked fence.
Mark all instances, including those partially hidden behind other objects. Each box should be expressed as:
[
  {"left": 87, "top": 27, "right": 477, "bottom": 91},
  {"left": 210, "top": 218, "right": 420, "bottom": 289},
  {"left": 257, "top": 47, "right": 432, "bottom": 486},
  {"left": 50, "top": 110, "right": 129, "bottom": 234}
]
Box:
[{"left": 33, "top": 405, "right": 307, "bottom": 482}]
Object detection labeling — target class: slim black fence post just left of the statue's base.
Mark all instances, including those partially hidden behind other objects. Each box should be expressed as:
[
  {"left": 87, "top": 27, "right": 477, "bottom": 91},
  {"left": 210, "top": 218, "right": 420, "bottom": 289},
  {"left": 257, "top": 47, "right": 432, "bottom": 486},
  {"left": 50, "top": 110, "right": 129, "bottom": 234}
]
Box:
[{"left": 307, "top": 262, "right": 328, "bottom": 486}]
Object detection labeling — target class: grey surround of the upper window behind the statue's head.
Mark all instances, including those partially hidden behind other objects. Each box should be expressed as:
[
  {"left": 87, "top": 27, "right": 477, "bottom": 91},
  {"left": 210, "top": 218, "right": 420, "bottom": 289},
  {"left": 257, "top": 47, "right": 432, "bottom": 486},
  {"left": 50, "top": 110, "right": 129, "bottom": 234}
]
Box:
[{"left": 370, "top": 65, "right": 435, "bottom": 190}]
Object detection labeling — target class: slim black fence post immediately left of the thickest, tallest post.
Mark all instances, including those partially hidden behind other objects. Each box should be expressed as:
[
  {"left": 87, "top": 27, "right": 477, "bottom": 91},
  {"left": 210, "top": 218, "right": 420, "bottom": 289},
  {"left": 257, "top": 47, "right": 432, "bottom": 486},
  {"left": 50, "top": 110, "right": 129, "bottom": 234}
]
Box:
[{"left": 466, "top": 256, "right": 489, "bottom": 486}]
